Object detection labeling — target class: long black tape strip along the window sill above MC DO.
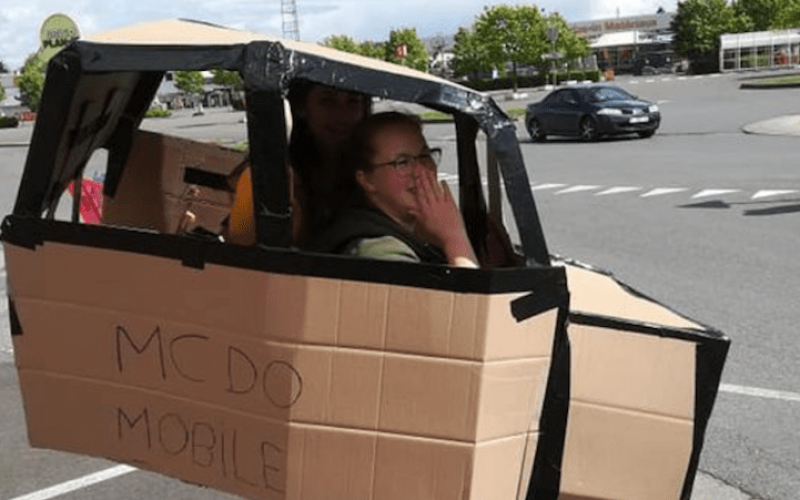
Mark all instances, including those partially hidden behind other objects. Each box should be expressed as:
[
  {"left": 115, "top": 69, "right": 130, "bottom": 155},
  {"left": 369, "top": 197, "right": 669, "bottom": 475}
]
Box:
[{"left": 2, "top": 215, "right": 566, "bottom": 293}]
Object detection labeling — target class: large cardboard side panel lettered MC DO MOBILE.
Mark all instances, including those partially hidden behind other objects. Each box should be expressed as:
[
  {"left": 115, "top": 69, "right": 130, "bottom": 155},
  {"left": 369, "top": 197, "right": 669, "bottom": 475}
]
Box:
[{"left": 4, "top": 235, "right": 556, "bottom": 500}]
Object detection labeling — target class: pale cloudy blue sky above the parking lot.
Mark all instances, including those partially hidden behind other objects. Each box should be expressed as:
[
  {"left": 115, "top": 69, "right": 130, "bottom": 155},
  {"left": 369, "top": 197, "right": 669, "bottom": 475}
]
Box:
[{"left": 0, "top": 0, "right": 677, "bottom": 69}]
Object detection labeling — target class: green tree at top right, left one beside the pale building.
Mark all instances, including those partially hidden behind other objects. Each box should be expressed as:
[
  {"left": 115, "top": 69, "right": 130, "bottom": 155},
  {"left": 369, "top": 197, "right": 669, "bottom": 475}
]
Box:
[{"left": 672, "top": 0, "right": 746, "bottom": 72}]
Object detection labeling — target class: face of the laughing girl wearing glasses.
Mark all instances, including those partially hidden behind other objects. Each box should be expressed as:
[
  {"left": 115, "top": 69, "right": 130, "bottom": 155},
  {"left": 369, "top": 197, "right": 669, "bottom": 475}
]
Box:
[{"left": 356, "top": 123, "right": 436, "bottom": 226}]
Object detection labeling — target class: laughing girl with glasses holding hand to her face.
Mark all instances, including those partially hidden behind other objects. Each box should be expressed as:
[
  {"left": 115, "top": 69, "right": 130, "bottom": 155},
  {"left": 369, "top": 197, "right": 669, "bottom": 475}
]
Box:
[{"left": 309, "top": 112, "right": 477, "bottom": 267}]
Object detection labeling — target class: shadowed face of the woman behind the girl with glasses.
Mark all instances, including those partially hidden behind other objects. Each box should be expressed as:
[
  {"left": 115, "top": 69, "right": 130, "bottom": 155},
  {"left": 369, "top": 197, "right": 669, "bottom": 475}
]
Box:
[{"left": 305, "top": 85, "right": 366, "bottom": 150}]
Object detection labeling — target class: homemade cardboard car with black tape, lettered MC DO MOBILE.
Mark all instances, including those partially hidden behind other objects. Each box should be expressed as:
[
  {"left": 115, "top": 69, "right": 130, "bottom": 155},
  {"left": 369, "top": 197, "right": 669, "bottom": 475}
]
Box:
[{"left": 0, "top": 21, "right": 729, "bottom": 500}]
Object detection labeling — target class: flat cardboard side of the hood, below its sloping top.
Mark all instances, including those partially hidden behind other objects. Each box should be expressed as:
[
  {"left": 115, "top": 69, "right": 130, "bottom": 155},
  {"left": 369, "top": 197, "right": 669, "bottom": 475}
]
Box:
[{"left": 561, "top": 324, "right": 696, "bottom": 500}]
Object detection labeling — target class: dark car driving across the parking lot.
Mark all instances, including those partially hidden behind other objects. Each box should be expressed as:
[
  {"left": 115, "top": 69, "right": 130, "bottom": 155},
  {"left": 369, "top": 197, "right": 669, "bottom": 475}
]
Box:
[{"left": 525, "top": 84, "right": 661, "bottom": 142}]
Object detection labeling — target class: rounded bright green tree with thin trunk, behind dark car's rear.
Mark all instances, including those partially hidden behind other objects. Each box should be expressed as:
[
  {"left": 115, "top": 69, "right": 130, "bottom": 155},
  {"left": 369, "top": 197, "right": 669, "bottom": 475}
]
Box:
[{"left": 474, "top": 4, "right": 549, "bottom": 90}]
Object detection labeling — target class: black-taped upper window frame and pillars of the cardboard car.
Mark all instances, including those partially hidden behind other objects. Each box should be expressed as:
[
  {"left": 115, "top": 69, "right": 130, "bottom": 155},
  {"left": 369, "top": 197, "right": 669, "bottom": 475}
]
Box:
[{"left": 14, "top": 36, "right": 549, "bottom": 265}]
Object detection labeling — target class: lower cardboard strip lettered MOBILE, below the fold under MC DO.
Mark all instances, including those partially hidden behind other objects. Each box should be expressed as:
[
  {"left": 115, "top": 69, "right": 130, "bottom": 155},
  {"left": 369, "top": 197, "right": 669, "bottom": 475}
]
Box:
[{"left": 20, "top": 370, "right": 540, "bottom": 500}]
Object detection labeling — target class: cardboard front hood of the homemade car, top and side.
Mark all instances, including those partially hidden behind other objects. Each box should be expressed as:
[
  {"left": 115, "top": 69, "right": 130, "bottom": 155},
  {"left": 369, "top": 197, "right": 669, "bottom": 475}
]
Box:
[{"left": 558, "top": 264, "right": 713, "bottom": 500}]
